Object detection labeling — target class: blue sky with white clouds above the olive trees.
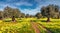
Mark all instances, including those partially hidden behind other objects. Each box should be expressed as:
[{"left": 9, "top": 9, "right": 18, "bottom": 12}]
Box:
[{"left": 0, "top": 0, "right": 60, "bottom": 15}]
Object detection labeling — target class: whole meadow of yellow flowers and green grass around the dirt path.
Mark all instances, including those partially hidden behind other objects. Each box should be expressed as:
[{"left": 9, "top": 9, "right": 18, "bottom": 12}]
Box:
[{"left": 0, "top": 18, "right": 60, "bottom": 33}]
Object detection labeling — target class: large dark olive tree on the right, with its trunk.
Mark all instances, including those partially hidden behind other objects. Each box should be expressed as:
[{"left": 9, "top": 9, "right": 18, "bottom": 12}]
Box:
[{"left": 41, "top": 5, "right": 60, "bottom": 22}]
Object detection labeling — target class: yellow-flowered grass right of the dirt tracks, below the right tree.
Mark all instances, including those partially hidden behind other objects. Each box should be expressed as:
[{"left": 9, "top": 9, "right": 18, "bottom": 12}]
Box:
[{"left": 38, "top": 19, "right": 60, "bottom": 33}]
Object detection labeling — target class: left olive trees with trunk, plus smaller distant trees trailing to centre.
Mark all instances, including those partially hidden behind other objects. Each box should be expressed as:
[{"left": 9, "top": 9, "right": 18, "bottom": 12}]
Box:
[{"left": 0, "top": 6, "right": 33, "bottom": 21}]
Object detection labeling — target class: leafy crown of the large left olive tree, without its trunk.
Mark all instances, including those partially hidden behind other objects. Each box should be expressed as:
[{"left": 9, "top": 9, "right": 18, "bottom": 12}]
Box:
[{"left": 0, "top": 6, "right": 21, "bottom": 18}]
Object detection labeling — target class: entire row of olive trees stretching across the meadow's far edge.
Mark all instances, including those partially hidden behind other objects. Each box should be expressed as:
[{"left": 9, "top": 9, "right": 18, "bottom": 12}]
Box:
[{"left": 0, "top": 4, "right": 60, "bottom": 22}]
